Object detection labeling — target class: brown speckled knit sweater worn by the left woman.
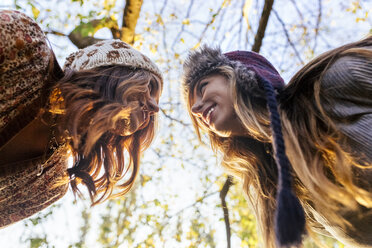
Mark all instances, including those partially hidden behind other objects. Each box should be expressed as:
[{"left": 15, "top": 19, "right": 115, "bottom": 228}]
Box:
[{"left": 0, "top": 10, "right": 68, "bottom": 228}]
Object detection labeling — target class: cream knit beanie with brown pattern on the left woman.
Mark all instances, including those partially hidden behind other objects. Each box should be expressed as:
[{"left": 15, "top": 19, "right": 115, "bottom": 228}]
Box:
[{"left": 64, "top": 40, "right": 163, "bottom": 81}]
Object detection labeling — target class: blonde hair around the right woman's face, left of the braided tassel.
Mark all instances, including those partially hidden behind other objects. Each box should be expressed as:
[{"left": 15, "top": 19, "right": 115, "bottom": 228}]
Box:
[{"left": 184, "top": 65, "right": 278, "bottom": 248}]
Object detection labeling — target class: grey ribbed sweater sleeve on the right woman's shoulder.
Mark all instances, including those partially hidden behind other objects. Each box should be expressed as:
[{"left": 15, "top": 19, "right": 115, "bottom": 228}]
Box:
[{"left": 321, "top": 51, "right": 372, "bottom": 163}]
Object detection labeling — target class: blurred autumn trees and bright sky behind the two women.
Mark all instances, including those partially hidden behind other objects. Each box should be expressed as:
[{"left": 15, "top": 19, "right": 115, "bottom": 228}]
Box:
[{"left": 0, "top": 0, "right": 372, "bottom": 248}]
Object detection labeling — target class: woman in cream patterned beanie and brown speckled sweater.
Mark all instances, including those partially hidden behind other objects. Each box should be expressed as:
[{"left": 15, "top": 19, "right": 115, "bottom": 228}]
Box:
[{"left": 0, "top": 10, "right": 163, "bottom": 227}]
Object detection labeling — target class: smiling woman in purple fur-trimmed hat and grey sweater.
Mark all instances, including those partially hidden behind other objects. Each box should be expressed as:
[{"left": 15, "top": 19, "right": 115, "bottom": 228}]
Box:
[{"left": 183, "top": 37, "right": 372, "bottom": 248}]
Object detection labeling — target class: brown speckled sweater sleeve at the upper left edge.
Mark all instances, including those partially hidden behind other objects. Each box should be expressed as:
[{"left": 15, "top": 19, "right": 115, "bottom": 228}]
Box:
[{"left": 0, "top": 10, "right": 52, "bottom": 147}]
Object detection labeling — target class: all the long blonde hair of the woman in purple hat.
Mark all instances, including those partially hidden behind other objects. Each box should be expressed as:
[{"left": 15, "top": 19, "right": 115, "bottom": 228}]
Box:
[{"left": 184, "top": 37, "right": 372, "bottom": 248}]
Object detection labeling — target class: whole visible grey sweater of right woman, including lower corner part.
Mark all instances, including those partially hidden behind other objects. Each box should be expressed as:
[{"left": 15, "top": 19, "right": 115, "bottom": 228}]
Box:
[{"left": 315, "top": 50, "right": 372, "bottom": 248}]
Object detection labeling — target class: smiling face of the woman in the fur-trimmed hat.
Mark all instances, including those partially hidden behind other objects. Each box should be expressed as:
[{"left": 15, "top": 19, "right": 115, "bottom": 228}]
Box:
[{"left": 191, "top": 74, "right": 245, "bottom": 137}]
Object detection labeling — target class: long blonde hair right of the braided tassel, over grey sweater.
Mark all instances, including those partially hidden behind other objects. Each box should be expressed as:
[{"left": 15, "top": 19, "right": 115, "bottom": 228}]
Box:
[{"left": 280, "top": 37, "right": 372, "bottom": 234}]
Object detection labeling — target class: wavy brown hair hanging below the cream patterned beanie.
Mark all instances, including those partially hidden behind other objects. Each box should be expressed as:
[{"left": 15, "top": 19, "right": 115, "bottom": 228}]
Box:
[{"left": 50, "top": 65, "right": 162, "bottom": 205}]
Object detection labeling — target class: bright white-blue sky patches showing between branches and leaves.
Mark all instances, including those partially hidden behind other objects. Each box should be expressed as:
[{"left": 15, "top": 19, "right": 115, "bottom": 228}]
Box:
[{"left": 0, "top": 0, "right": 372, "bottom": 248}]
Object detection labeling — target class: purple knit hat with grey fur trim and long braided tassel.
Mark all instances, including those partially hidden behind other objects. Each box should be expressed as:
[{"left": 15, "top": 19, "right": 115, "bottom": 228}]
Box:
[{"left": 182, "top": 45, "right": 305, "bottom": 247}]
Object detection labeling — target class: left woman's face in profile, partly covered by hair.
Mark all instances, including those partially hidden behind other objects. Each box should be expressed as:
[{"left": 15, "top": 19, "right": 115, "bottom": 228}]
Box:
[{"left": 124, "top": 80, "right": 161, "bottom": 136}]
